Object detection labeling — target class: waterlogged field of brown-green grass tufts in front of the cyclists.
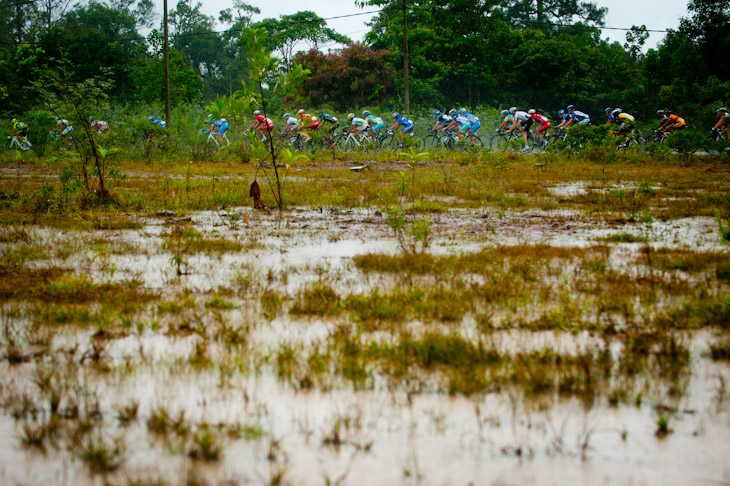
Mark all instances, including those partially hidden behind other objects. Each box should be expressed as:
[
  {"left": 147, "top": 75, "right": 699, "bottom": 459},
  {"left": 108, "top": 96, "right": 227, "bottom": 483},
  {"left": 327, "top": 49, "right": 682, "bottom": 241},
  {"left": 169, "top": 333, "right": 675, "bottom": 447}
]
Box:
[{"left": 0, "top": 158, "right": 730, "bottom": 486}]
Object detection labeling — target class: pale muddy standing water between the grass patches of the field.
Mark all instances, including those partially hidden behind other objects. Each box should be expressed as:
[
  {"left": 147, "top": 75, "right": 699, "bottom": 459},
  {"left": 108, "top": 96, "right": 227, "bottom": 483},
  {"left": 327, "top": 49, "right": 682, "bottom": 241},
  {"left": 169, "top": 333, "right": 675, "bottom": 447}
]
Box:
[{"left": 0, "top": 208, "right": 730, "bottom": 486}]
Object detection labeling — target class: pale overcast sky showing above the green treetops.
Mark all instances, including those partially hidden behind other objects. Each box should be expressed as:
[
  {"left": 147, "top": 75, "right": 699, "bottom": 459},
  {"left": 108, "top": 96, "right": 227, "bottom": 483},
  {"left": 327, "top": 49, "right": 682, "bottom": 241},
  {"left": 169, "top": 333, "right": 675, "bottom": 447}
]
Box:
[{"left": 175, "top": 0, "right": 687, "bottom": 49}]
